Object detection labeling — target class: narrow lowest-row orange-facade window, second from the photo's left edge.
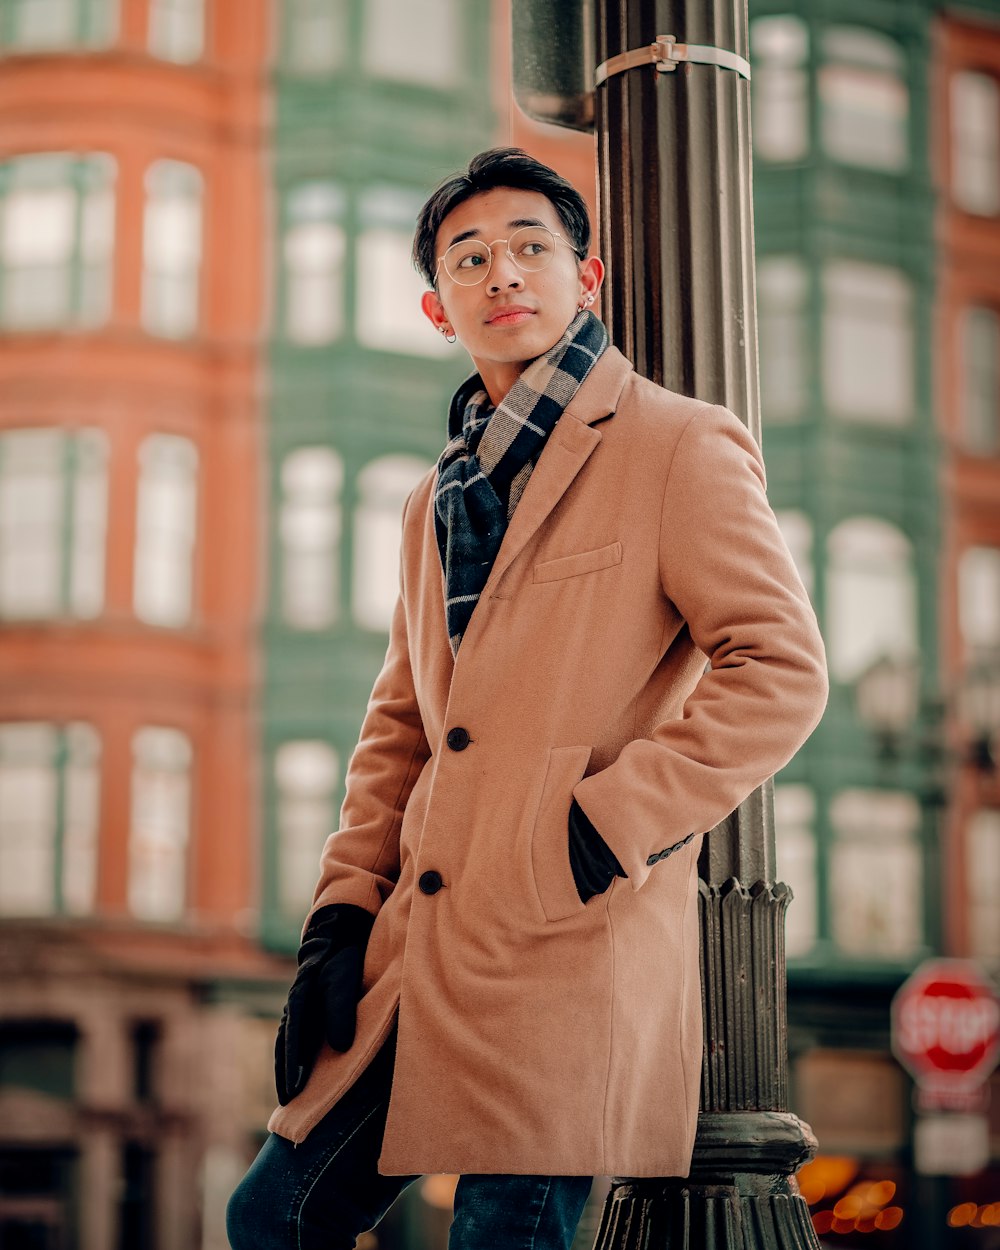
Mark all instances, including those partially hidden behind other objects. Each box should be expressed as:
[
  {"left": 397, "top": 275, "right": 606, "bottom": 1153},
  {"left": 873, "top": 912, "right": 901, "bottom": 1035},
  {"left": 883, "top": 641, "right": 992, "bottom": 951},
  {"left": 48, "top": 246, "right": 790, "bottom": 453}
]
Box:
[{"left": 129, "top": 728, "right": 191, "bottom": 921}]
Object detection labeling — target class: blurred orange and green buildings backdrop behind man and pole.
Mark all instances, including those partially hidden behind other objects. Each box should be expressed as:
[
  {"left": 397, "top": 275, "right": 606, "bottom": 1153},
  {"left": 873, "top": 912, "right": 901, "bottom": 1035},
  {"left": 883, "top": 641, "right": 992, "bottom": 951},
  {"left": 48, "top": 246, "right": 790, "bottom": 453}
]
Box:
[{"left": 0, "top": 0, "right": 1000, "bottom": 1250}]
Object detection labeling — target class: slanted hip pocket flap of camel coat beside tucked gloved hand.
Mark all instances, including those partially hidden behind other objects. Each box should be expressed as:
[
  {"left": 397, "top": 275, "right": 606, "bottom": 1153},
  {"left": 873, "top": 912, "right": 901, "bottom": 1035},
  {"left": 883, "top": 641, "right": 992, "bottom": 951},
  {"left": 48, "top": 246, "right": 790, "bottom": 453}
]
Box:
[{"left": 531, "top": 746, "right": 593, "bottom": 920}]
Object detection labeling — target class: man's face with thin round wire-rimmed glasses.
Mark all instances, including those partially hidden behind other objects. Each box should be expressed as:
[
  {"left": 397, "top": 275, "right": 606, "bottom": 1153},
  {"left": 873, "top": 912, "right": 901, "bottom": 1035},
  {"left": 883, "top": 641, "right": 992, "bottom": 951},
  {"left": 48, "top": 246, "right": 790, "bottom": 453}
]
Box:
[{"left": 423, "top": 188, "right": 604, "bottom": 393}]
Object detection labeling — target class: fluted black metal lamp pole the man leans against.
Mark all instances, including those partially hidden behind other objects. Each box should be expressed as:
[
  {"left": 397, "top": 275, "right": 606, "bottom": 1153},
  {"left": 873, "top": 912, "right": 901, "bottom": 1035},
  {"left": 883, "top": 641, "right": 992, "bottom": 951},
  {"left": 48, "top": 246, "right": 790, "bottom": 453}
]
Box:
[{"left": 595, "top": 0, "right": 819, "bottom": 1250}]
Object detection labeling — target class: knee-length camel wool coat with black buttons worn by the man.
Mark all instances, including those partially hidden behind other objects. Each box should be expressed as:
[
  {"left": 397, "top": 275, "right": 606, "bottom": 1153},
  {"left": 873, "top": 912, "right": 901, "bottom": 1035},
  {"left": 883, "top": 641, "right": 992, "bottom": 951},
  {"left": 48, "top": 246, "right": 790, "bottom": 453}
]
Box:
[{"left": 270, "top": 349, "right": 826, "bottom": 1176}]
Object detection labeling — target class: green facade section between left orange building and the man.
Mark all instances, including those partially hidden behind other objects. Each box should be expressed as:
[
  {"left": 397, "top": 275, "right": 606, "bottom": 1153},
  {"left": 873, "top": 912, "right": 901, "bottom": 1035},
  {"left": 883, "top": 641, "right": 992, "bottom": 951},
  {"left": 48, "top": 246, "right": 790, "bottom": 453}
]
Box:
[{"left": 261, "top": 0, "right": 494, "bottom": 950}]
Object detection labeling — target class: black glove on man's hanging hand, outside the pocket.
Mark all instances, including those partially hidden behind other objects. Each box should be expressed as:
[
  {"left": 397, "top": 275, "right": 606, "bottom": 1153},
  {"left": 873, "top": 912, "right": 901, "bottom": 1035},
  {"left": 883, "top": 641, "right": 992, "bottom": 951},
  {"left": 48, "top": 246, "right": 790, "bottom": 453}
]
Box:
[{"left": 274, "top": 903, "right": 375, "bottom": 1106}]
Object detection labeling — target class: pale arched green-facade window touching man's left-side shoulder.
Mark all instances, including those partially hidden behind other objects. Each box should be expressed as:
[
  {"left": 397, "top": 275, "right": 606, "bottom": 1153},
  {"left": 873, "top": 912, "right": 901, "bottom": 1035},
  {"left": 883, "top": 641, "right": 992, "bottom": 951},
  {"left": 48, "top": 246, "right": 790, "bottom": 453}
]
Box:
[{"left": 353, "top": 456, "right": 430, "bottom": 630}]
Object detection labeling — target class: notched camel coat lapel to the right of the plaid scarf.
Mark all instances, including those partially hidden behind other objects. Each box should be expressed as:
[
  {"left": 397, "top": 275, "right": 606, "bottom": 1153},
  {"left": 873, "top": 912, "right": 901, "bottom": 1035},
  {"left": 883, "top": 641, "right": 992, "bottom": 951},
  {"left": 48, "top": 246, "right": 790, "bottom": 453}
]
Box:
[{"left": 459, "top": 346, "right": 633, "bottom": 630}]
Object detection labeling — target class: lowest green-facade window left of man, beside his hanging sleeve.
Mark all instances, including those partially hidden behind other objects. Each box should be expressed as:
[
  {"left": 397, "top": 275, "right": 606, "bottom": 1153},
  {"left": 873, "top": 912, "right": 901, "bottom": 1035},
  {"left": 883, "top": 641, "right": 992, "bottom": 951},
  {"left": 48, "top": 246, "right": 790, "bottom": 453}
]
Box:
[{"left": 274, "top": 741, "right": 340, "bottom": 921}]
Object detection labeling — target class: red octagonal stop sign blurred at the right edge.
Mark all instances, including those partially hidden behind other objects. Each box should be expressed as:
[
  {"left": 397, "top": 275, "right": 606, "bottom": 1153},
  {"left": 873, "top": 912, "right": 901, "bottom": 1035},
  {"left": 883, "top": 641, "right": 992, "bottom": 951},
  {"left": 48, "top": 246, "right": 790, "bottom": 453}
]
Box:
[{"left": 893, "top": 959, "right": 1000, "bottom": 1089}]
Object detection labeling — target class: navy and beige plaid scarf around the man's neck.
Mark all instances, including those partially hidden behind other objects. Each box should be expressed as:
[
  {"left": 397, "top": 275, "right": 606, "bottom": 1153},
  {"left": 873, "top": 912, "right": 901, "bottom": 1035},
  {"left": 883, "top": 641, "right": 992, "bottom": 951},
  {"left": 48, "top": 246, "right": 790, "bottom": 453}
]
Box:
[{"left": 434, "top": 310, "right": 608, "bottom": 655}]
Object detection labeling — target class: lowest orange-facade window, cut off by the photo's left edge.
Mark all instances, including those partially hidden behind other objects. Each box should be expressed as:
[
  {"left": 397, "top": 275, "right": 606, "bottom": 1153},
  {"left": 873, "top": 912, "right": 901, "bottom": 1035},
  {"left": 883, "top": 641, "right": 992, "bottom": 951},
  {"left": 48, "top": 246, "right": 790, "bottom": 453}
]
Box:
[{"left": 0, "top": 721, "right": 100, "bottom": 915}]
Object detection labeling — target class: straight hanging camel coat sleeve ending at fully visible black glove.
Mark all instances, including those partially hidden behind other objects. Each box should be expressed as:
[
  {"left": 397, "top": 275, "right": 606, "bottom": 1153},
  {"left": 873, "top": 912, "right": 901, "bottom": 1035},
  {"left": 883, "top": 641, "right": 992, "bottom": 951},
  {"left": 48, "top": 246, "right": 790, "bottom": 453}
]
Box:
[{"left": 306, "top": 500, "right": 430, "bottom": 926}]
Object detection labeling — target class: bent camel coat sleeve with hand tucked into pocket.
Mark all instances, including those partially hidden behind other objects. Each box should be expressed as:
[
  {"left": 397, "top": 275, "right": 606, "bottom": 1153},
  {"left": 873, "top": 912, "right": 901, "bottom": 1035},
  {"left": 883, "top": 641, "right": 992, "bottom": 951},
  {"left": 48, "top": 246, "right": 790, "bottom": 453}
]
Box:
[{"left": 574, "top": 408, "right": 828, "bottom": 890}]
